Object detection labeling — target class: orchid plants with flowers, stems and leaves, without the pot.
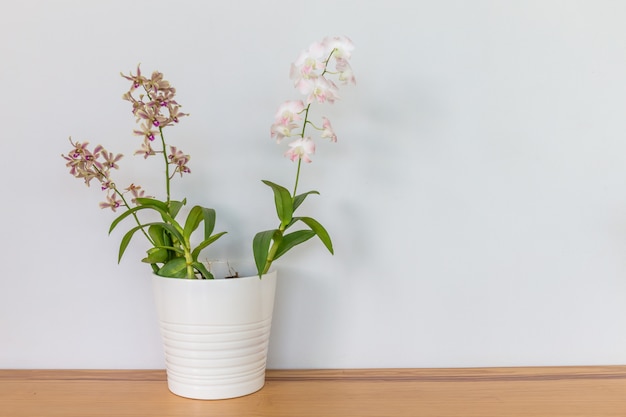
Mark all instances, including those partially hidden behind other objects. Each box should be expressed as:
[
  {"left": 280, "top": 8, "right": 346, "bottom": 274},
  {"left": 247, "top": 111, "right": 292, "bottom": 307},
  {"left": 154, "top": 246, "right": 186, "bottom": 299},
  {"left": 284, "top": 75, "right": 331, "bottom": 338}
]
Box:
[{"left": 62, "top": 37, "right": 355, "bottom": 279}]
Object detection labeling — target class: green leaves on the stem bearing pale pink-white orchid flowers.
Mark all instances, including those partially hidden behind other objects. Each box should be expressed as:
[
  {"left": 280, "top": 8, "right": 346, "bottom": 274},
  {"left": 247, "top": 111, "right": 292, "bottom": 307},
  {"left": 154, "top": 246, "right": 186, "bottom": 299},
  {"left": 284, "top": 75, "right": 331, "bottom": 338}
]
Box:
[{"left": 252, "top": 180, "right": 334, "bottom": 276}]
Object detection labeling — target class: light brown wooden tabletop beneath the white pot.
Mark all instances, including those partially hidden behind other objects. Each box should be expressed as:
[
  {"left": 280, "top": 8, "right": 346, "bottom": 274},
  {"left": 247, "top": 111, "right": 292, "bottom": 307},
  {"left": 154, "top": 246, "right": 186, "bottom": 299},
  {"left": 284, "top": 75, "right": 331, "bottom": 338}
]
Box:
[{"left": 0, "top": 366, "right": 626, "bottom": 417}]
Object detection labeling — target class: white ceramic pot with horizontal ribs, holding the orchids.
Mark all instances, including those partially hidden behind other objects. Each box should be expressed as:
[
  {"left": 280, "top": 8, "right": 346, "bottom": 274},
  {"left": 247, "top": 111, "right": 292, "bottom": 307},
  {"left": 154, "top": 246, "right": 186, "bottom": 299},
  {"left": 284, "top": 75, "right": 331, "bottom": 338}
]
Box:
[{"left": 153, "top": 271, "right": 276, "bottom": 400}]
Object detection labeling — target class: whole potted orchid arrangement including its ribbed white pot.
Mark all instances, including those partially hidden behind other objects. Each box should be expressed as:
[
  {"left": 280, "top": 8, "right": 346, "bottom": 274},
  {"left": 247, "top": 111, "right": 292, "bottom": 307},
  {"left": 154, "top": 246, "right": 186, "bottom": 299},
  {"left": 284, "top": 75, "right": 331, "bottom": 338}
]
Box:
[{"left": 62, "top": 37, "right": 355, "bottom": 399}]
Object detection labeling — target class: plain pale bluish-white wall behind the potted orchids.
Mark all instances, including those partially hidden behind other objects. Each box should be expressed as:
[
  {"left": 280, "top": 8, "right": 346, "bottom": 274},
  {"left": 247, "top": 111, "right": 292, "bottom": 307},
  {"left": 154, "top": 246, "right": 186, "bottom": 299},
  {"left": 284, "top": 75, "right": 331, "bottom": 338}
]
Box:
[{"left": 0, "top": 0, "right": 626, "bottom": 368}]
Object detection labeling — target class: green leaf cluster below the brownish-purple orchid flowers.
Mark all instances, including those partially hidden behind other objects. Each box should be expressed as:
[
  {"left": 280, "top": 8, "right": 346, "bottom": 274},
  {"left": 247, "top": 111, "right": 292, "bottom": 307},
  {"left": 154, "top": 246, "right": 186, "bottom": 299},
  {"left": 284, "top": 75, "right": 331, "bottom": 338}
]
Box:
[{"left": 109, "top": 198, "right": 226, "bottom": 279}]
